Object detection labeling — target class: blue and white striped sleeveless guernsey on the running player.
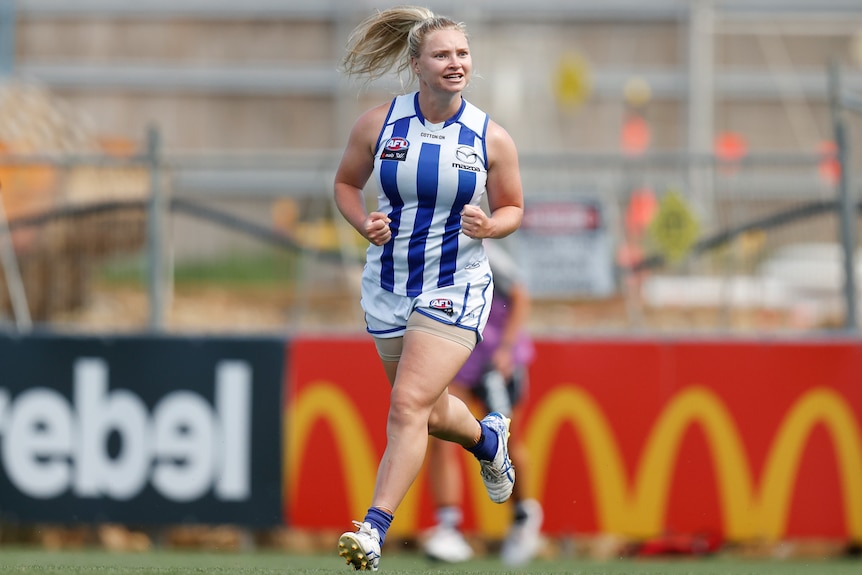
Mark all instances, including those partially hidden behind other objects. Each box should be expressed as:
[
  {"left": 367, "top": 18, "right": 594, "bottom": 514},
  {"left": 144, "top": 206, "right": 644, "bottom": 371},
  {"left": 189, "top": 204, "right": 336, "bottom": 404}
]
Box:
[{"left": 365, "top": 92, "right": 488, "bottom": 297}]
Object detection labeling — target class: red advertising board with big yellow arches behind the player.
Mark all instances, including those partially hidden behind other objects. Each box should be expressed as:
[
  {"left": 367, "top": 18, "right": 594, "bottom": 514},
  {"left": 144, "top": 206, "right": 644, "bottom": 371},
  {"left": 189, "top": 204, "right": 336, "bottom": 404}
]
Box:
[{"left": 284, "top": 337, "right": 862, "bottom": 541}]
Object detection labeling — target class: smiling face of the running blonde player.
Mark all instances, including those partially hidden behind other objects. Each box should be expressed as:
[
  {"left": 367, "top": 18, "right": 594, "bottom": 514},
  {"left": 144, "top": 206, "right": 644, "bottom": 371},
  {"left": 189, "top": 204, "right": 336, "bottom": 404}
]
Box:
[{"left": 413, "top": 30, "right": 473, "bottom": 92}]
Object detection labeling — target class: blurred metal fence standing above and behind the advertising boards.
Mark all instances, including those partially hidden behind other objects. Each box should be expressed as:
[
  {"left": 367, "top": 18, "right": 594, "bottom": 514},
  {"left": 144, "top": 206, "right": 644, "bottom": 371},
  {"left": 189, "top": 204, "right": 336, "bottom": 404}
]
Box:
[{"left": 0, "top": 86, "right": 860, "bottom": 338}]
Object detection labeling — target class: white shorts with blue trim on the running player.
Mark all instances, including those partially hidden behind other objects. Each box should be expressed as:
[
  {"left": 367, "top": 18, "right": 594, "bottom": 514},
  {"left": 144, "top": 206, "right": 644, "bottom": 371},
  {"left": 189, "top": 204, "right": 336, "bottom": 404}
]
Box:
[{"left": 361, "top": 260, "right": 494, "bottom": 341}]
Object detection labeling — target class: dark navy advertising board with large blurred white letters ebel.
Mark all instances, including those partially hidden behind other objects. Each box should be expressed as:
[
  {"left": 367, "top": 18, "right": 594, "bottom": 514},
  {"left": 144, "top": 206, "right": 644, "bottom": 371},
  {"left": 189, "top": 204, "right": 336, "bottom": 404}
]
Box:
[{"left": 0, "top": 336, "right": 285, "bottom": 525}]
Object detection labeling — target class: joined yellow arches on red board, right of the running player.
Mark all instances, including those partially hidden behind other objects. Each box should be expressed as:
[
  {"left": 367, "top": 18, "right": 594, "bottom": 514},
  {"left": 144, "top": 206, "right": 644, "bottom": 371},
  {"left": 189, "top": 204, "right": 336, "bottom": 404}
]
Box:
[{"left": 525, "top": 386, "right": 862, "bottom": 540}]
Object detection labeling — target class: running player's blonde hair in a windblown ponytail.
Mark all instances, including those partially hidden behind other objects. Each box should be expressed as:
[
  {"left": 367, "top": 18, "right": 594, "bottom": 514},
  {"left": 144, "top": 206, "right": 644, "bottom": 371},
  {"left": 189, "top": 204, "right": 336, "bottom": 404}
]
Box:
[{"left": 341, "top": 6, "right": 467, "bottom": 84}]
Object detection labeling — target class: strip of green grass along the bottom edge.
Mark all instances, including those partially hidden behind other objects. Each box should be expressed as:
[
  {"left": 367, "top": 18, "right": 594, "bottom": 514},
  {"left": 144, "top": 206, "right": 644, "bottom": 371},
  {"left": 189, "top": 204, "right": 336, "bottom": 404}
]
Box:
[{"left": 0, "top": 547, "right": 862, "bottom": 575}]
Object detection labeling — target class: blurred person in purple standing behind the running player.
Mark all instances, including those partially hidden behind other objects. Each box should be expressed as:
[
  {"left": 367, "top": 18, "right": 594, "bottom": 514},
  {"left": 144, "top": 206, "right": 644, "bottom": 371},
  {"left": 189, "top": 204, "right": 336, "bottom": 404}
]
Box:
[{"left": 424, "top": 241, "right": 543, "bottom": 566}]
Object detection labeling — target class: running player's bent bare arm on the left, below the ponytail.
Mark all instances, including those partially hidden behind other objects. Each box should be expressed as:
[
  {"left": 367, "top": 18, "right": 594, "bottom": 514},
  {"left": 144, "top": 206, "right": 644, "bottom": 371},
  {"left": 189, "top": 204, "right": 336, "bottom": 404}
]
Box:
[{"left": 335, "top": 104, "right": 392, "bottom": 246}]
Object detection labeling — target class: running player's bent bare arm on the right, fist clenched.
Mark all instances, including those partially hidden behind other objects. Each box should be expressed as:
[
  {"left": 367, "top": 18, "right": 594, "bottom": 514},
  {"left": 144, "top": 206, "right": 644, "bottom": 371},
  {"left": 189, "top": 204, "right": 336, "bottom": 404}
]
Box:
[{"left": 461, "top": 122, "right": 524, "bottom": 239}]
